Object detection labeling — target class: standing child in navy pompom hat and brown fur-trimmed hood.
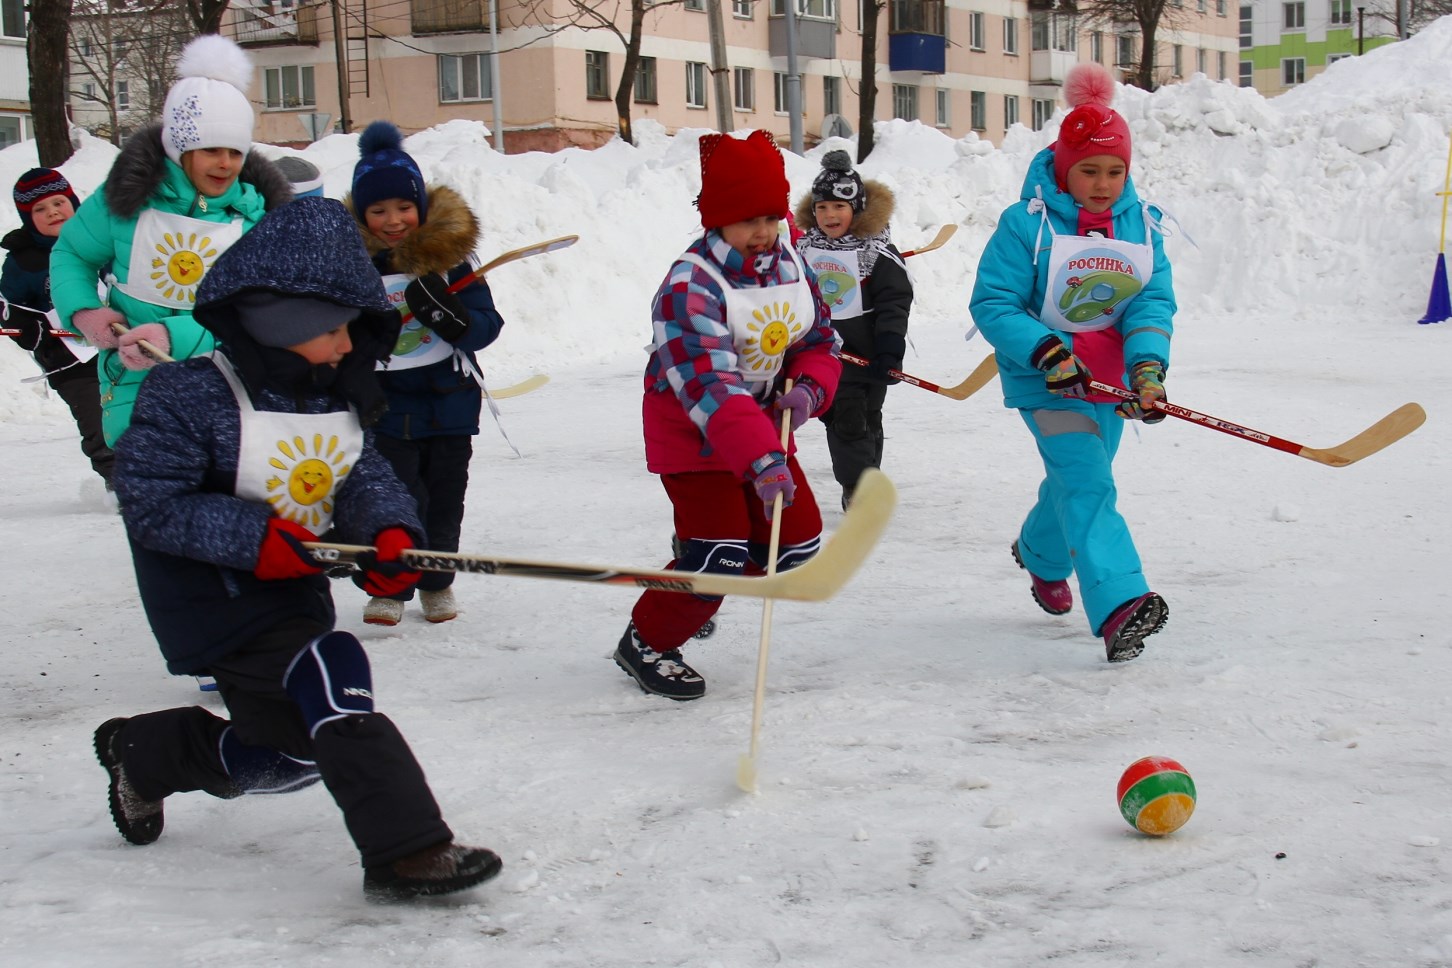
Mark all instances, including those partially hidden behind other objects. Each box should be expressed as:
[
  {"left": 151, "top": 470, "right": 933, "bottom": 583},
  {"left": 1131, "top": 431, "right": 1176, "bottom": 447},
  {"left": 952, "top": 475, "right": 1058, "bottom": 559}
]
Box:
[{"left": 344, "top": 120, "right": 504, "bottom": 625}]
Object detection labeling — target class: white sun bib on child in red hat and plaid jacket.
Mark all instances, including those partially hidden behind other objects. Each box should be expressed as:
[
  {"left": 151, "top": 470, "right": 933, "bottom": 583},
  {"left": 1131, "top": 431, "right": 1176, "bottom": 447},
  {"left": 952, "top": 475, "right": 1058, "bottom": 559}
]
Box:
[{"left": 681, "top": 247, "right": 816, "bottom": 385}]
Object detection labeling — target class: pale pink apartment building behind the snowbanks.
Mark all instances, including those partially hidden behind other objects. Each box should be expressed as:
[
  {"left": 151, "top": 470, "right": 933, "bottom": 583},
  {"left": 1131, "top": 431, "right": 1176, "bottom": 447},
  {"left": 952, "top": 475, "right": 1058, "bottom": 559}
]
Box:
[{"left": 224, "top": 0, "right": 1237, "bottom": 152}]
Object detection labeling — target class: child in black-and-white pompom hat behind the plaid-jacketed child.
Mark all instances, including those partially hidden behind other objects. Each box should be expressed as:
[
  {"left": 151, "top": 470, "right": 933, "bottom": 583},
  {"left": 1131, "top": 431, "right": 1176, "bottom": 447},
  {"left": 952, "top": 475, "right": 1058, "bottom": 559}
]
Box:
[{"left": 796, "top": 151, "right": 912, "bottom": 511}]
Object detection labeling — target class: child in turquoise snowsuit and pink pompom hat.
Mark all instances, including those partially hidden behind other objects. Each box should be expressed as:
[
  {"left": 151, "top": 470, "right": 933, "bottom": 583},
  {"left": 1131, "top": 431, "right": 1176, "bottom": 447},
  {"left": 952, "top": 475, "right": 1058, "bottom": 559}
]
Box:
[{"left": 971, "top": 64, "right": 1176, "bottom": 662}]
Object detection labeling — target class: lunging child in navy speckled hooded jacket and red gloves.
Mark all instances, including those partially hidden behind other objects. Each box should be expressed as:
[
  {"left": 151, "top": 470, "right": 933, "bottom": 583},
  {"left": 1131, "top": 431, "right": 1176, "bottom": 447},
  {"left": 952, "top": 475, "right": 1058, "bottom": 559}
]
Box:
[{"left": 96, "top": 199, "right": 499, "bottom": 900}]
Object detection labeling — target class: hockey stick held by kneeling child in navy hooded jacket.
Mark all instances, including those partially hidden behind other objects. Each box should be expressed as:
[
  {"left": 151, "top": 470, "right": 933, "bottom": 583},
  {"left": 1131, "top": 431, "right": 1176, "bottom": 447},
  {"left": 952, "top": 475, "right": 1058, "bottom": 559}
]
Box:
[{"left": 305, "top": 469, "right": 897, "bottom": 602}]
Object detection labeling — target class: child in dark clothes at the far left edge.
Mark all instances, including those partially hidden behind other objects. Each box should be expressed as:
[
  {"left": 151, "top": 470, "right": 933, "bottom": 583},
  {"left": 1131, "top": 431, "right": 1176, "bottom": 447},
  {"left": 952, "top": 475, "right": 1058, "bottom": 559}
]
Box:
[{"left": 0, "top": 168, "right": 115, "bottom": 493}]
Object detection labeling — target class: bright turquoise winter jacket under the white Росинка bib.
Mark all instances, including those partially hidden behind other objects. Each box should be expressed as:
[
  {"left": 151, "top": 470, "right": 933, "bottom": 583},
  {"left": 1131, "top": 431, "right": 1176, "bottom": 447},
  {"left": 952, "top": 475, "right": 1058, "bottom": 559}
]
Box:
[{"left": 970, "top": 148, "right": 1176, "bottom": 409}]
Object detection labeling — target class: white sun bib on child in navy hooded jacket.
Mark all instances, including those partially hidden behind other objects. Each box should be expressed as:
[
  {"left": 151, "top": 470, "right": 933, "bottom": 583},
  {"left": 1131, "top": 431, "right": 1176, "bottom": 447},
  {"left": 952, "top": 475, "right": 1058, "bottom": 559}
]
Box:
[{"left": 211, "top": 353, "right": 363, "bottom": 534}]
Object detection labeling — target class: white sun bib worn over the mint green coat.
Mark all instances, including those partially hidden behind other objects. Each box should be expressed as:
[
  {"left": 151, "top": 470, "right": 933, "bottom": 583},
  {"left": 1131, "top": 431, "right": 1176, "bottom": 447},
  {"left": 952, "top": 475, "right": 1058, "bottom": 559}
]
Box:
[{"left": 116, "top": 209, "right": 242, "bottom": 312}]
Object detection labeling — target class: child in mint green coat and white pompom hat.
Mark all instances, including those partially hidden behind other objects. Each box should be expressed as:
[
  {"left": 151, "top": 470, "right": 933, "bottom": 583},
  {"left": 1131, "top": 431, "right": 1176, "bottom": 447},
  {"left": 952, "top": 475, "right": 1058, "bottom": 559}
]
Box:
[{"left": 51, "top": 35, "right": 290, "bottom": 446}]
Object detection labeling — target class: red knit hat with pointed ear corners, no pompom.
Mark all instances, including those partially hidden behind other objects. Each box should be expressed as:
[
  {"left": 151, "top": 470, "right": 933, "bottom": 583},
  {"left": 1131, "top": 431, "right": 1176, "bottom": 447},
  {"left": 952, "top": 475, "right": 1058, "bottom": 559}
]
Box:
[{"left": 696, "top": 131, "right": 791, "bottom": 228}]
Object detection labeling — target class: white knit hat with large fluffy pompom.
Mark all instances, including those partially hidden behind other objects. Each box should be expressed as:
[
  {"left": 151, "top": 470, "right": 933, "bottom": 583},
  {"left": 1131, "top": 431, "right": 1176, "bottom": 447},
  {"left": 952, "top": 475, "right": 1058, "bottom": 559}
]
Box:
[{"left": 161, "top": 33, "right": 254, "bottom": 164}]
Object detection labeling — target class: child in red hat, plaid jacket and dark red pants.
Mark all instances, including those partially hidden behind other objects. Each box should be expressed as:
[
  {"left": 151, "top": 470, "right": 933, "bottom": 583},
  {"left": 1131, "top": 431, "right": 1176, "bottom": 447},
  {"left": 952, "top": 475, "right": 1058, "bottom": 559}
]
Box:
[{"left": 614, "top": 131, "right": 842, "bottom": 700}]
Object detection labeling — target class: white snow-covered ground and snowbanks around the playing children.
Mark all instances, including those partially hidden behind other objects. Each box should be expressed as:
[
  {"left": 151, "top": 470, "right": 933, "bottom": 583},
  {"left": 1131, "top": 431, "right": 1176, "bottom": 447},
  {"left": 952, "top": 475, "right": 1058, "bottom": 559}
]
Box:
[{"left": 8, "top": 19, "right": 1452, "bottom": 968}]
